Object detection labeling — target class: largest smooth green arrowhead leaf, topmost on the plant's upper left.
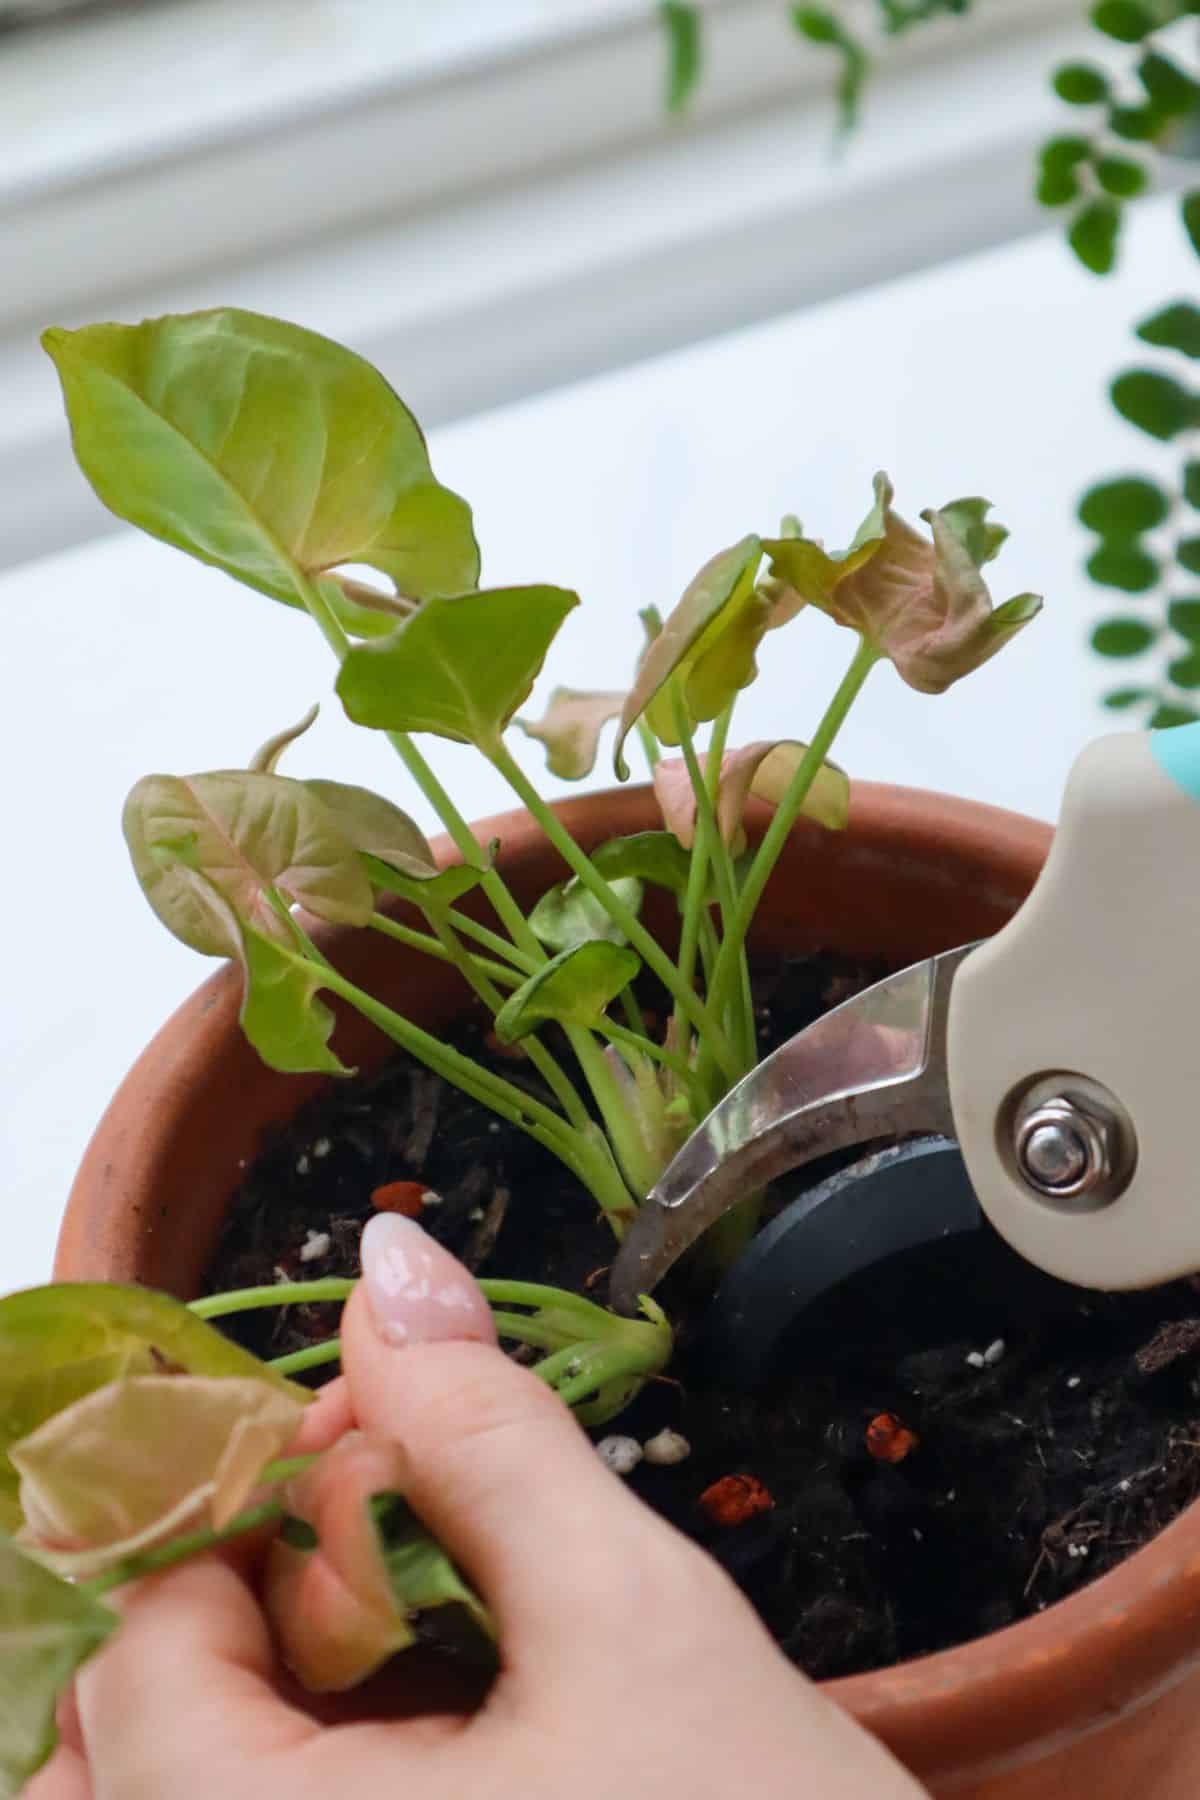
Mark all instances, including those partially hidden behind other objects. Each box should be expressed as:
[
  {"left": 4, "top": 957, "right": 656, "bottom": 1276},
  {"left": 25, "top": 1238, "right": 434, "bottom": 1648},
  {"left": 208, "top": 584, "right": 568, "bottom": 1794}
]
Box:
[{"left": 41, "top": 310, "right": 479, "bottom": 605}]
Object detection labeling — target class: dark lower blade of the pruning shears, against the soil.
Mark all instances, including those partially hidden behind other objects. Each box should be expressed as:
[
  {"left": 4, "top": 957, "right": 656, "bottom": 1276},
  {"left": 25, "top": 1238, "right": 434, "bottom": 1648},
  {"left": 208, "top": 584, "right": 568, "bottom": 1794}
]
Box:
[{"left": 694, "top": 1138, "right": 982, "bottom": 1388}]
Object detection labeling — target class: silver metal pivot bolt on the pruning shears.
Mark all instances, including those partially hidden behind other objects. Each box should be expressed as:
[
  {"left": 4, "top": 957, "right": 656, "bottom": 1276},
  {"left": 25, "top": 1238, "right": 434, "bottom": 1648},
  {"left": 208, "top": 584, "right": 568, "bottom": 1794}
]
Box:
[{"left": 1013, "top": 1084, "right": 1130, "bottom": 1206}]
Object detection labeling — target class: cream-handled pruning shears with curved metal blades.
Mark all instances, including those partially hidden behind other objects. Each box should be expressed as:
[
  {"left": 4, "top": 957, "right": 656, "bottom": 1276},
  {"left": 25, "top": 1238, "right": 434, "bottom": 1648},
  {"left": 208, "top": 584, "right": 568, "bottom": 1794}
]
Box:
[{"left": 612, "top": 724, "right": 1200, "bottom": 1381}]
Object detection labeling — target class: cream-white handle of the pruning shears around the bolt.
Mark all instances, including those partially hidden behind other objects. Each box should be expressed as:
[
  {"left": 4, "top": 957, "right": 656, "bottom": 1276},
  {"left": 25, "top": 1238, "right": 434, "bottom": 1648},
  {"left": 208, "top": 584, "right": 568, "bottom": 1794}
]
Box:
[{"left": 946, "top": 725, "right": 1200, "bottom": 1289}]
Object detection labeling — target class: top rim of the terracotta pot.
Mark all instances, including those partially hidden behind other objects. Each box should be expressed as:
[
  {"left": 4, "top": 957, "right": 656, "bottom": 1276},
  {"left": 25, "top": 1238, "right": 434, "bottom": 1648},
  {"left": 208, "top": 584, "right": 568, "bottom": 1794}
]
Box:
[{"left": 54, "top": 781, "right": 1200, "bottom": 1786}]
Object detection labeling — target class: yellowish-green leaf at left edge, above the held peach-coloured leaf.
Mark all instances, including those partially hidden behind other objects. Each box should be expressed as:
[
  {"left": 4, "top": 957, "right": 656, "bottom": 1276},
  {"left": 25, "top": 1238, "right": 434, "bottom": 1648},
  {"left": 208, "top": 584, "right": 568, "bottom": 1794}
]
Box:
[{"left": 0, "top": 1282, "right": 308, "bottom": 1530}]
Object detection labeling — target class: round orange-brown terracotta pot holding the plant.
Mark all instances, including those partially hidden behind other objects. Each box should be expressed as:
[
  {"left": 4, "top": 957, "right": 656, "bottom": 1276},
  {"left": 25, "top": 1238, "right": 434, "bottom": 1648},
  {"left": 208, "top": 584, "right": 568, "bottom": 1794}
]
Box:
[{"left": 56, "top": 783, "right": 1200, "bottom": 1800}]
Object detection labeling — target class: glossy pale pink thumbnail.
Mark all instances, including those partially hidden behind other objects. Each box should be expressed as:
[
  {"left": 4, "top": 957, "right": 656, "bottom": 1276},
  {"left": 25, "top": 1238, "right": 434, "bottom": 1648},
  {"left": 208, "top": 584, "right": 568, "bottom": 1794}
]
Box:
[{"left": 362, "top": 1213, "right": 497, "bottom": 1345}]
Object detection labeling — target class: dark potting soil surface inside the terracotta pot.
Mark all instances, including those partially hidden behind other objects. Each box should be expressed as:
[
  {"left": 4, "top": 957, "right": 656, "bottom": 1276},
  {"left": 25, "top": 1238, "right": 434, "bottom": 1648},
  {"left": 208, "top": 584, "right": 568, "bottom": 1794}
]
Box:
[{"left": 207, "top": 956, "right": 1200, "bottom": 1678}]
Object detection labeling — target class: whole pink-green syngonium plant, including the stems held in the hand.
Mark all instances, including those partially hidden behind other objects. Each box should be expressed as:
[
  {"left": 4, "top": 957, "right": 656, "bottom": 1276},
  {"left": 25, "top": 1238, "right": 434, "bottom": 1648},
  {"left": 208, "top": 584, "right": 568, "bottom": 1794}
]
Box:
[{"left": 0, "top": 311, "right": 1040, "bottom": 1800}]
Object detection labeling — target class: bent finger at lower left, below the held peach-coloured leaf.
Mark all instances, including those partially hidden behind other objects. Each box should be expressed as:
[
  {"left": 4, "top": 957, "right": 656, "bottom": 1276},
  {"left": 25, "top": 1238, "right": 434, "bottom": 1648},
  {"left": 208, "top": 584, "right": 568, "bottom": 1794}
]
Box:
[{"left": 77, "top": 1557, "right": 317, "bottom": 1800}]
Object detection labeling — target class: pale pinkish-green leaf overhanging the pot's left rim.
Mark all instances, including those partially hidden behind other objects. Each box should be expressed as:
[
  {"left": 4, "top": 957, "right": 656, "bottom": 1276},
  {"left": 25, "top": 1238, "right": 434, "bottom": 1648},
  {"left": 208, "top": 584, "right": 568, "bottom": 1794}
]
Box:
[{"left": 122, "top": 769, "right": 372, "bottom": 956}]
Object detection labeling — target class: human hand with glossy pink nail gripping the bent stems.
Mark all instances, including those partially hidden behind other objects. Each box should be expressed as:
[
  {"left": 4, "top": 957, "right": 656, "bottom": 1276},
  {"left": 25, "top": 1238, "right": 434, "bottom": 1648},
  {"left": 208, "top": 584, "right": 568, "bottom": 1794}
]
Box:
[{"left": 29, "top": 1215, "right": 923, "bottom": 1800}]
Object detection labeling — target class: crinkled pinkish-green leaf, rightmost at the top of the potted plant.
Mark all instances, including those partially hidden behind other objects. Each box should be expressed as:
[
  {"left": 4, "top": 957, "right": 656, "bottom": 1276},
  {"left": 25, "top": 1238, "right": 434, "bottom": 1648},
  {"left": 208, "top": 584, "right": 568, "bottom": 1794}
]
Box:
[{"left": 765, "top": 475, "right": 1042, "bottom": 693}]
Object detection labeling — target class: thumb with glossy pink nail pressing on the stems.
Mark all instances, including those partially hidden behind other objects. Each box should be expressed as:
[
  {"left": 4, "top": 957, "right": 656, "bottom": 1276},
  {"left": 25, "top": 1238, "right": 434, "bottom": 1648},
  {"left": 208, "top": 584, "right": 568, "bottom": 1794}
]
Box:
[{"left": 342, "top": 1213, "right": 698, "bottom": 1672}]
